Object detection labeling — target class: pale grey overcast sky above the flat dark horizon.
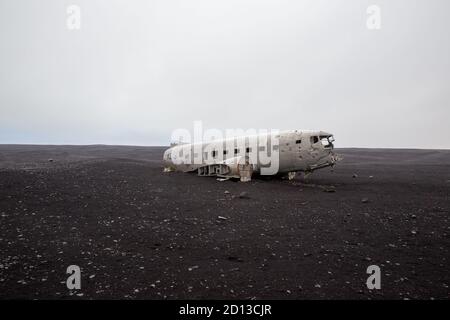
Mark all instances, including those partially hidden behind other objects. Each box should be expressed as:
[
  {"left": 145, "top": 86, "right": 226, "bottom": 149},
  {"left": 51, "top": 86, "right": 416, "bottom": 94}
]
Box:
[{"left": 0, "top": 0, "right": 450, "bottom": 148}]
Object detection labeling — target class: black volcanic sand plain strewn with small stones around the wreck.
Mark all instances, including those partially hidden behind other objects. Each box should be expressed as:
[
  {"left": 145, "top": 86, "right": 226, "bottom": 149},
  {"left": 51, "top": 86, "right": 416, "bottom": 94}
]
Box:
[{"left": 0, "top": 145, "right": 450, "bottom": 299}]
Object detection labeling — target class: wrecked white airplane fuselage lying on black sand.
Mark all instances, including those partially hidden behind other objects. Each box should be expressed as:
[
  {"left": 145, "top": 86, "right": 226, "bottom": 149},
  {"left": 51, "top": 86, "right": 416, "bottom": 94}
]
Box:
[{"left": 163, "top": 130, "right": 337, "bottom": 180}]
